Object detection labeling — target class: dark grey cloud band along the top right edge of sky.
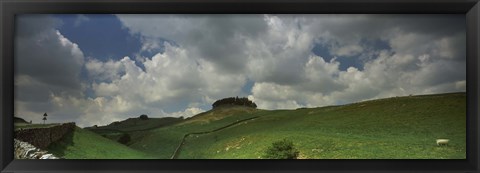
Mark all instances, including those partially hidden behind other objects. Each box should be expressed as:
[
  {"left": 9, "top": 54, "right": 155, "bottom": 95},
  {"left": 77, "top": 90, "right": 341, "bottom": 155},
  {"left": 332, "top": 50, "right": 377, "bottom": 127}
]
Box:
[{"left": 306, "top": 14, "right": 465, "bottom": 41}]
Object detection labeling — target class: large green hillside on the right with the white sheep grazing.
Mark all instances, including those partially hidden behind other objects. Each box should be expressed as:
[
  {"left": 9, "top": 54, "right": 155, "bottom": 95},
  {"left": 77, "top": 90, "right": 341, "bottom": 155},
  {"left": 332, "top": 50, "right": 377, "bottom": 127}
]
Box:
[{"left": 124, "top": 93, "right": 466, "bottom": 159}]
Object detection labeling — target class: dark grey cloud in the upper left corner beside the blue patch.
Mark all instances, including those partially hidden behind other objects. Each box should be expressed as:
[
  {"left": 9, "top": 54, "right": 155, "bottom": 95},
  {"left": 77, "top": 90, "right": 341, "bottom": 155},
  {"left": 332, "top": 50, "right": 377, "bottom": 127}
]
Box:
[{"left": 15, "top": 15, "right": 84, "bottom": 92}]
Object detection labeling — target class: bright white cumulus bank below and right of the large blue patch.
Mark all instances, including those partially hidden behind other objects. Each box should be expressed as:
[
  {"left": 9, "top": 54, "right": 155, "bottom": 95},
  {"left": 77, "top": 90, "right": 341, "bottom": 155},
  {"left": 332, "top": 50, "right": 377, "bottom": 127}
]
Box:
[{"left": 78, "top": 43, "right": 246, "bottom": 124}]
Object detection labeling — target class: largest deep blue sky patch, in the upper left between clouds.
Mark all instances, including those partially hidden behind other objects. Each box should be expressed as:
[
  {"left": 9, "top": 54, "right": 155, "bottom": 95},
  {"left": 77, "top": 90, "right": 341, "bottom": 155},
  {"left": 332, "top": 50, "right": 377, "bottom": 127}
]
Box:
[{"left": 55, "top": 14, "right": 142, "bottom": 61}]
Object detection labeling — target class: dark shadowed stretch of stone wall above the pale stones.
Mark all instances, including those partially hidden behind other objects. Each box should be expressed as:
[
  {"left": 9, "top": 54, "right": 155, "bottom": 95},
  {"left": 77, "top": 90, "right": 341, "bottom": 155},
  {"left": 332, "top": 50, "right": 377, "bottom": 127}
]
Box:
[{"left": 15, "top": 123, "right": 76, "bottom": 149}]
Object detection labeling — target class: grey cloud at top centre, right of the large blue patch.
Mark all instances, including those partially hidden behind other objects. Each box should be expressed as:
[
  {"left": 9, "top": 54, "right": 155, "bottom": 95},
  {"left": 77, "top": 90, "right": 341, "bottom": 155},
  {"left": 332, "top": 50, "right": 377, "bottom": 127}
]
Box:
[{"left": 117, "top": 14, "right": 266, "bottom": 73}]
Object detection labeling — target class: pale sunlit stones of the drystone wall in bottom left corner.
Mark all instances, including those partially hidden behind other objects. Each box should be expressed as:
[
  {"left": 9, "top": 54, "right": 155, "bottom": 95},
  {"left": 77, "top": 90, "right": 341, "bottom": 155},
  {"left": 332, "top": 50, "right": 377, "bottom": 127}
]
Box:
[{"left": 14, "top": 139, "right": 60, "bottom": 159}]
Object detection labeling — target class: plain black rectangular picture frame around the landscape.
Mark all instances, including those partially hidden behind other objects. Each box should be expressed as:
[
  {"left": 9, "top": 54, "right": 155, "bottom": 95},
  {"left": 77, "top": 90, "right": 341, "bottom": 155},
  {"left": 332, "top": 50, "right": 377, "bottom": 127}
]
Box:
[{"left": 0, "top": 0, "right": 480, "bottom": 173}]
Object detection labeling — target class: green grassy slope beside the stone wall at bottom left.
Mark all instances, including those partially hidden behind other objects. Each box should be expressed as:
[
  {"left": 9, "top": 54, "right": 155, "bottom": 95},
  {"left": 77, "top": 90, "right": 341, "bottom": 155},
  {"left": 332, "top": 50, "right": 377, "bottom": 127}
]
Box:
[{"left": 48, "top": 127, "right": 155, "bottom": 159}]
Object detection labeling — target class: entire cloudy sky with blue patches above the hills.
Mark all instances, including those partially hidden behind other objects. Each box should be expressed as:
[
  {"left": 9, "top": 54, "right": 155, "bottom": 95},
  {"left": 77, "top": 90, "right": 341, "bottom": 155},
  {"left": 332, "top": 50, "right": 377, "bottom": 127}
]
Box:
[{"left": 15, "top": 14, "right": 466, "bottom": 127}]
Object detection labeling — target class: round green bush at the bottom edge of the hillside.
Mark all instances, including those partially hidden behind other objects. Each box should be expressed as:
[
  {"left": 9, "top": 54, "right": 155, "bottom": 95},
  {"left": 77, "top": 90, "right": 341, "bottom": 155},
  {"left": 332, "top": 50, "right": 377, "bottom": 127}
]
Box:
[{"left": 264, "top": 139, "right": 299, "bottom": 159}]
